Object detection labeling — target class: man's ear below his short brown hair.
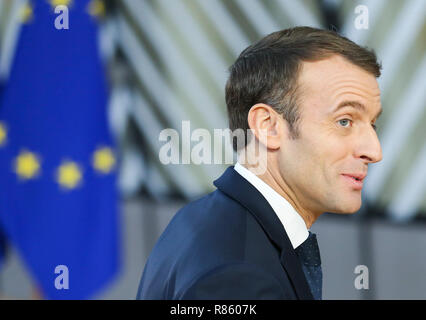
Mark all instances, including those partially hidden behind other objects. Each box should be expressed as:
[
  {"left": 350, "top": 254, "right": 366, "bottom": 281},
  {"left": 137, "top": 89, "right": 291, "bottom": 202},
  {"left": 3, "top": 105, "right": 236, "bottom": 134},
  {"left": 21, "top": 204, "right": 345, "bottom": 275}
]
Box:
[{"left": 247, "top": 103, "right": 286, "bottom": 150}]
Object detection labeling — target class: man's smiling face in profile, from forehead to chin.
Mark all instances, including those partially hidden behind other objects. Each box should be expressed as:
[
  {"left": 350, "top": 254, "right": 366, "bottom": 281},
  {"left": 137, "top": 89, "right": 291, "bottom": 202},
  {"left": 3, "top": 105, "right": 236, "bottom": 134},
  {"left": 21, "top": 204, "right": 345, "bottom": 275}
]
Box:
[{"left": 279, "top": 55, "right": 382, "bottom": 213}]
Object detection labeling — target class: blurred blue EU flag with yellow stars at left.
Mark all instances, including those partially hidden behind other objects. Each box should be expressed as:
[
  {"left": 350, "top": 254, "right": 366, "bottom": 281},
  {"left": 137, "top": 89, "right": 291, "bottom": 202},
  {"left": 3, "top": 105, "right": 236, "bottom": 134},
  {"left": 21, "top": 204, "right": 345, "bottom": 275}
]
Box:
[{"left": 0, "top": 0, "right": 120, "bottom": 299}]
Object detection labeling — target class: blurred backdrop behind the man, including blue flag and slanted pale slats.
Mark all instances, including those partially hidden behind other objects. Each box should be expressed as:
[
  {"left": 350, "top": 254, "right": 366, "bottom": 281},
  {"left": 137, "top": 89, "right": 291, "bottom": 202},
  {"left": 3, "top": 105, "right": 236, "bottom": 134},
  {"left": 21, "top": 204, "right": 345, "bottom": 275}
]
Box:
[{"left": 0, "top": 0, "right": 426, "bottom": 299}]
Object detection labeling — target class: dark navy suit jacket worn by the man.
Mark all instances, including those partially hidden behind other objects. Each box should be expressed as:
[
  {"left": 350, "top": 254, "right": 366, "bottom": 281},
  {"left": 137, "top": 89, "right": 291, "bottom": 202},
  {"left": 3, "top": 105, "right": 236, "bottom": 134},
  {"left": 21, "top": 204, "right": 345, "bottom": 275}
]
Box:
[{"left": 137, "top": 167, "right": 313, "bottom": 300}]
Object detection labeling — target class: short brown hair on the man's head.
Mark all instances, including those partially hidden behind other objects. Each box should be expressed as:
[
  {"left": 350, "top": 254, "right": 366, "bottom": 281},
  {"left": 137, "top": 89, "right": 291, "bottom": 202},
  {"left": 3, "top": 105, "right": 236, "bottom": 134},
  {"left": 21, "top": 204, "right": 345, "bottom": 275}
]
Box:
[{"left": 225, "top": 27, "right": 381, "bottom": 150}]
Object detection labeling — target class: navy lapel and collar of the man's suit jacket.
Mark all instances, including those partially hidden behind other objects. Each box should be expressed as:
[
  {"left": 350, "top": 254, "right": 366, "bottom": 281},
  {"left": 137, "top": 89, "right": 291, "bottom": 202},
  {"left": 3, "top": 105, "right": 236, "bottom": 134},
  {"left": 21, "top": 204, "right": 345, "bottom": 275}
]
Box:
[{"left": 214, "top": 166, "right": 313, "bottom": 300}]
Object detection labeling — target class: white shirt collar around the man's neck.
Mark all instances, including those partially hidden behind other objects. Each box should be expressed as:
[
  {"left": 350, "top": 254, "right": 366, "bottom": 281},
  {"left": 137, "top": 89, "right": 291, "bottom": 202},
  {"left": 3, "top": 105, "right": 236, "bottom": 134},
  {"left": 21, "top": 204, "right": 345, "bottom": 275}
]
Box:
[{"left": 234, "top": 162, "right": 309, "bottom": 249}]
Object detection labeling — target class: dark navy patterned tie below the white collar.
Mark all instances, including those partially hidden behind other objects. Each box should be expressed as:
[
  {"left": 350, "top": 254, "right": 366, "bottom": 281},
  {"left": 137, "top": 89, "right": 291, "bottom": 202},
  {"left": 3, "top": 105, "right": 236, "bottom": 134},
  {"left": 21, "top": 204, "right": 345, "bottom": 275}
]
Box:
[{"left": 295, "top": 231, "right": 322, "bottom": 300}]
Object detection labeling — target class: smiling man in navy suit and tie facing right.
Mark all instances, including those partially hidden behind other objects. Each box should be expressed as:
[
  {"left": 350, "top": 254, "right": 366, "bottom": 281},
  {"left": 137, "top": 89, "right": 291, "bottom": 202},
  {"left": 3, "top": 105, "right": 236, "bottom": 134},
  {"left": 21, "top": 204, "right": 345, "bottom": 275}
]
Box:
[{"left": 137, "top": 27, "right": 382, "bottom": 299}]
